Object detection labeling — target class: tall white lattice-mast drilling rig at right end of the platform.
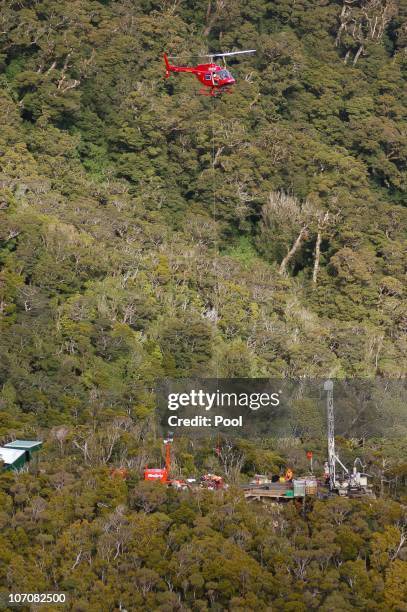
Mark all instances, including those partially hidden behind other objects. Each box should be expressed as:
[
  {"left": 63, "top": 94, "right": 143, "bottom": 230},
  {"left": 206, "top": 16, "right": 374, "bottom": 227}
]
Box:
[{"left": 324, "top": 379, "right": 373, "bottom": 497}]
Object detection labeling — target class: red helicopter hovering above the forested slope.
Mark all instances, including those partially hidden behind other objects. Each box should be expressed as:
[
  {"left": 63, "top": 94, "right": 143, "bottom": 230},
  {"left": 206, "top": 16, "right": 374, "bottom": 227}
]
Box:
[{"left": 164, "top": 49, "right": 256, "bottom": 96}]
